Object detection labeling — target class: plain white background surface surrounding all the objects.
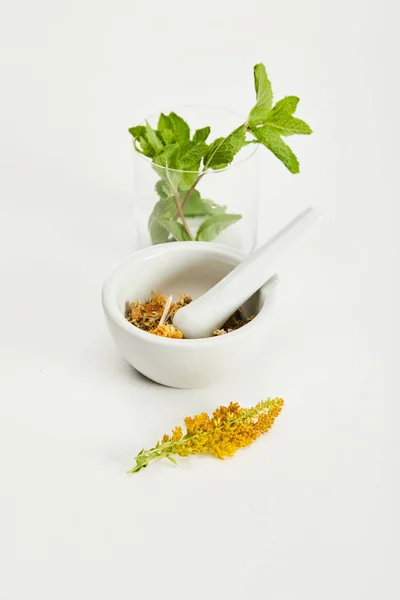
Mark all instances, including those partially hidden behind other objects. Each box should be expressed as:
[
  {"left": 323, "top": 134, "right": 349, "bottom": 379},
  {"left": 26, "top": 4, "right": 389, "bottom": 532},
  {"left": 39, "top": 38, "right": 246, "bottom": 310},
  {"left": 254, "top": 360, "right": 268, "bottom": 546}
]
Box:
[{"left": 0, "top": 0, "right": 400, "bottom": 600}]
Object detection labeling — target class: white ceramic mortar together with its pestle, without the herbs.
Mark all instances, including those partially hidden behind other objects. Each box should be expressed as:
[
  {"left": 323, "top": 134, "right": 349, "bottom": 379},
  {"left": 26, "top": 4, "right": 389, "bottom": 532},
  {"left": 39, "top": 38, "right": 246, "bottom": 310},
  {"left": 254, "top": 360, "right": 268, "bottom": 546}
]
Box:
[{"left": 102, "top": 207, "right": 319, "bottom": 388}]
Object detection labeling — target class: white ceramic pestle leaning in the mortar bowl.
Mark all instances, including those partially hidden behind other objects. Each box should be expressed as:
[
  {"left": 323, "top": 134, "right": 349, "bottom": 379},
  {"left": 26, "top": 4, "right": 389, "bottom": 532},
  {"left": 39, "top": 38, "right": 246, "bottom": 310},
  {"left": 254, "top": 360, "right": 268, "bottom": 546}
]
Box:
[{"left": 173, "top": 206, "right": 319, "bottom": 339}]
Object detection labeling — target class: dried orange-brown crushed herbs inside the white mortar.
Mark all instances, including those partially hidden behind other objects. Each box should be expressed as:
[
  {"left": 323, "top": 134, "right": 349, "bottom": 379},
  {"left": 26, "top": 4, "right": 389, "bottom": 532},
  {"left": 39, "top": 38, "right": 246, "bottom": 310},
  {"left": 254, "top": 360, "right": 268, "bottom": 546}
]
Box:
[{"left": 125, "top": 292, "right": 254, "bottom": 339}]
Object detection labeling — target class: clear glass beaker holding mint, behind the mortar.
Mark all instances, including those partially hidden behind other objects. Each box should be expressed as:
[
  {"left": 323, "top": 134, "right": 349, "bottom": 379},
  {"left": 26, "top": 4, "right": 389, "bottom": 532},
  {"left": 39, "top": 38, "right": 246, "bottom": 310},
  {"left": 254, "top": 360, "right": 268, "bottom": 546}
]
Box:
[{"left": 133, "top": 106, "right": 259, "bottom": 253}]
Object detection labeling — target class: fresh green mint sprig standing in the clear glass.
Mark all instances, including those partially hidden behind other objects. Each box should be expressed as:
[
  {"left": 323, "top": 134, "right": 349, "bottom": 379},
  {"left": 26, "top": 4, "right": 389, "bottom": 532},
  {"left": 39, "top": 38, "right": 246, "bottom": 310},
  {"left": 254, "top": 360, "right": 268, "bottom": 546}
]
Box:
[{"left": 129, "top": 63, "right": 312, "bottom": 244}]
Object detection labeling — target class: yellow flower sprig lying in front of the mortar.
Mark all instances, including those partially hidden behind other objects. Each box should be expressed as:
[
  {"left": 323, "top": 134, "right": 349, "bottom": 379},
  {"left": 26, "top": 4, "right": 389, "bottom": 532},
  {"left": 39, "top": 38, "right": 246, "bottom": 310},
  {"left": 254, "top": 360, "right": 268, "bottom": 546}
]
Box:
[{"left": 128, "top": 398, "right": 284, "bottom": 473}]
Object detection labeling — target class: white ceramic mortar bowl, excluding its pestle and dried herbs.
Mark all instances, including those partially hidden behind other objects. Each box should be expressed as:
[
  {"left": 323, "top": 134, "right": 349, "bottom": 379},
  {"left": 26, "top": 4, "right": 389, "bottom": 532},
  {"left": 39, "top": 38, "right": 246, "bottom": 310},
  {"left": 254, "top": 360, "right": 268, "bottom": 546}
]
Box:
[{"left": 102, "top": 242, "right": 279, "bottom": 389}]
